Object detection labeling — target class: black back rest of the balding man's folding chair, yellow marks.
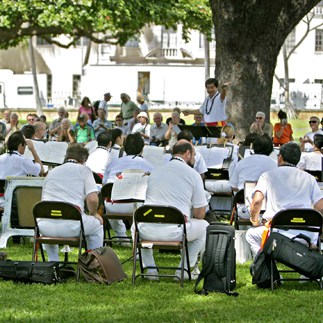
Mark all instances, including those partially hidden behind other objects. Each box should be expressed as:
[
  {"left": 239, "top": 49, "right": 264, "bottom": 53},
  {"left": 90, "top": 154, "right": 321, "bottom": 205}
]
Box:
[{"left": 134, "top": 205, "right": 185, "bottom": 228}]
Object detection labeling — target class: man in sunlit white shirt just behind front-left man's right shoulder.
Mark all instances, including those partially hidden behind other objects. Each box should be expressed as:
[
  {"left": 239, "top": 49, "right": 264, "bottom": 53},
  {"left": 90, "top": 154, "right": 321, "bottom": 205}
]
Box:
[{"left": 86, "top": 131, "right": 112, "bottom": 178}]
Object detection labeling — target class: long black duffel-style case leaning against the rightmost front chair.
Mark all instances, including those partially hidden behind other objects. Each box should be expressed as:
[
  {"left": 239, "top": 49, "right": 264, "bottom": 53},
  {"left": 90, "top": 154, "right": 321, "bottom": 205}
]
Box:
[{"left": 263, "top": 232, "right": 323, "bottom": 279}]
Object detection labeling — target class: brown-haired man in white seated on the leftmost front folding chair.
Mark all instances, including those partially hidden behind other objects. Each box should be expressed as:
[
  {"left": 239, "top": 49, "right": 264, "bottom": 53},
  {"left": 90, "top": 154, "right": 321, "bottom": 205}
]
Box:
[{"left": 39, "top": 145, "right": 103, "bottom": 261}]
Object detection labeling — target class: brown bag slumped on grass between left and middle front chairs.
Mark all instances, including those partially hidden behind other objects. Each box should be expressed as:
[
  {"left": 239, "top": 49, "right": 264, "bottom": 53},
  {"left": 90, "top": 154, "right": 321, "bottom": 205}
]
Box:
[{"left": 78, "top": 247, "right": 127, "bottom": 284}]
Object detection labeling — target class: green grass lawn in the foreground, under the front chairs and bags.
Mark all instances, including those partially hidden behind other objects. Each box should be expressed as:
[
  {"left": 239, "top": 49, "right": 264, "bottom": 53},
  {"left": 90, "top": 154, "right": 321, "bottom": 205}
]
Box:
[{"left": 0, "top": 242, "right": 323, "bottom": 322}]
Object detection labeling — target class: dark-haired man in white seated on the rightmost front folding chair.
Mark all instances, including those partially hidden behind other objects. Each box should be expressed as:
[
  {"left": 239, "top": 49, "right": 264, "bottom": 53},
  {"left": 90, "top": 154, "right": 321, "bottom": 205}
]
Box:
[{"left": 246, "top": 142, "right": 323, "bottom": 255}]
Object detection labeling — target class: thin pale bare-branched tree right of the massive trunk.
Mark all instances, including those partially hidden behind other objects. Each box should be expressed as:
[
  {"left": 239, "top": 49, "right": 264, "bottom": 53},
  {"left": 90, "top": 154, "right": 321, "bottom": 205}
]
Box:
[{"left": 275, "top": 11, "right": 323, "bottom": 118}]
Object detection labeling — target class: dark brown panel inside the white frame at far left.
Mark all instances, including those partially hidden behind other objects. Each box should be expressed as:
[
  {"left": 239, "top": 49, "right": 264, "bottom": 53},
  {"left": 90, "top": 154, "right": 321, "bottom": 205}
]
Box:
[{"left": 14, "top": 186, "right": 42, "bottom": 228}]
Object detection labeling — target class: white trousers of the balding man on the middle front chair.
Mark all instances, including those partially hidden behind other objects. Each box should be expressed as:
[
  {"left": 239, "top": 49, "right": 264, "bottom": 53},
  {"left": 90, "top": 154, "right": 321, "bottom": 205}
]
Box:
[{"left": 131, "top": 219, "right": 209, "bottom": 267}]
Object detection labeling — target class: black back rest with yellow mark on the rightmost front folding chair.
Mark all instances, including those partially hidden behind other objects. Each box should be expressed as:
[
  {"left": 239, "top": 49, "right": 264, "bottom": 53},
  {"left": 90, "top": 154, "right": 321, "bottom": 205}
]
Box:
[{"left": 271, "top": 209, "right": 323, "bottom": 233}]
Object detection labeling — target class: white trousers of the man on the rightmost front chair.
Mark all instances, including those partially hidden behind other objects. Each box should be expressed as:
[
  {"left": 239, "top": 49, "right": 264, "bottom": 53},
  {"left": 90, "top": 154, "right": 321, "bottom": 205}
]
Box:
[{"left": 246, "top": 225, "right": 318, "bottom": 257}]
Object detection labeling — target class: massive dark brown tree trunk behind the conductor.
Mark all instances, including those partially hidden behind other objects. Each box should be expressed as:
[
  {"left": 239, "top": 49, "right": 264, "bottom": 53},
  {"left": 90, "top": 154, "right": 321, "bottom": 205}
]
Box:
[{"left": 210, "top": 0, "right": 319, "bottom": 138}]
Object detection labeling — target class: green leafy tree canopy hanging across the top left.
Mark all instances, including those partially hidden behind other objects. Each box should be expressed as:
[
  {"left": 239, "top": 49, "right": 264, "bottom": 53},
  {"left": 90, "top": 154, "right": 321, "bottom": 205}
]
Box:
[{"left": 0, "top": 0, "right": 212, "bottom": 48}]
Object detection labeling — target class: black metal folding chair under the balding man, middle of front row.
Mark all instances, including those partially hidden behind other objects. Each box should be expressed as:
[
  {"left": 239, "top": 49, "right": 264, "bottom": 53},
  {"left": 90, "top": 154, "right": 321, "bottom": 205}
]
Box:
[{"left": 132, "top": 205, "right": 191, "bottom": 287}]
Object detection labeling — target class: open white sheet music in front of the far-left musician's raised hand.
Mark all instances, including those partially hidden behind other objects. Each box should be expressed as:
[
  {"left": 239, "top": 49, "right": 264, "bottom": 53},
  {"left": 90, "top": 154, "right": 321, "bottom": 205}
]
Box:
[{"left": 24, "top": 140, "right": 68, "bottom": 164}]
